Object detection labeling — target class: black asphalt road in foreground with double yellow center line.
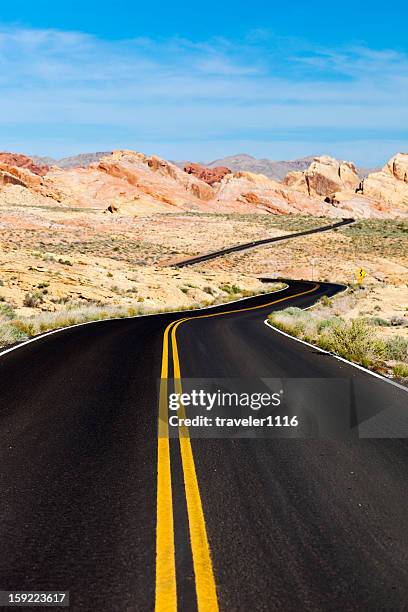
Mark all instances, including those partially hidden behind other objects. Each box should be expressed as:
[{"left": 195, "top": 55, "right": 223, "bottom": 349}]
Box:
[{"left": 0, "top": 282, "right": 408, "bottom": 612}]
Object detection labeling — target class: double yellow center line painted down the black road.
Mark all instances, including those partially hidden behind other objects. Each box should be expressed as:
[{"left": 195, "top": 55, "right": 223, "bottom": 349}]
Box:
[{"left": 155, "top": 283, "right": 320, "bottom": 612}]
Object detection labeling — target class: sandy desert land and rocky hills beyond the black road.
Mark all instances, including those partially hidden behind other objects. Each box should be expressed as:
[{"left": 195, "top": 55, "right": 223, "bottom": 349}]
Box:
[{"left": 0, "top": 151, "right": 408, "bottom": 378}]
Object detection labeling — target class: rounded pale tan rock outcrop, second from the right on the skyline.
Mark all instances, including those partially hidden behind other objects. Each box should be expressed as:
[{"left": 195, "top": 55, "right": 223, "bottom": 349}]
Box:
[{"left": 283, "top": 156, "right": 360, "bottom": 197}]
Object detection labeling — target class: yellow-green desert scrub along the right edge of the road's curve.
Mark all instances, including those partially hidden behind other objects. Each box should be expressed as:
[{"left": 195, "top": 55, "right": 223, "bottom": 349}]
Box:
[{"left": 269, "top": 296, "right": 408, "bottom": 377}]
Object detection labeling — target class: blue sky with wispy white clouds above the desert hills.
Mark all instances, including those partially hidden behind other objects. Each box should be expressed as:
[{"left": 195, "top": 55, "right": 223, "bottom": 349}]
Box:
[{"left": 0, "top": 0, "right": 408, "bottom": 165}]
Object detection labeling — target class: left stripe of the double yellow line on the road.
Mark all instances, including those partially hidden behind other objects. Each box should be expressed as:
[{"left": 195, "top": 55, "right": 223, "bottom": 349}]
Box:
[{"left": 155, "top": 323, "right": 177, "bottom": 612}]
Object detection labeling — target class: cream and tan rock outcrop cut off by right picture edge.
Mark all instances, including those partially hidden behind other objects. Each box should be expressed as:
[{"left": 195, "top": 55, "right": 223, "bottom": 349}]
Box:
[{"left": 360, "top": 153, "right": 408, "bottom": 209}]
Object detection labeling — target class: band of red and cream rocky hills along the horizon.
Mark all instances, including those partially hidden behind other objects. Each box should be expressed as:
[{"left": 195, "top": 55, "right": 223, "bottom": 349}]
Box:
[{"left": 0, "top": 151, "right": 408, "bottom": 218}]
